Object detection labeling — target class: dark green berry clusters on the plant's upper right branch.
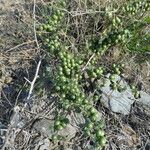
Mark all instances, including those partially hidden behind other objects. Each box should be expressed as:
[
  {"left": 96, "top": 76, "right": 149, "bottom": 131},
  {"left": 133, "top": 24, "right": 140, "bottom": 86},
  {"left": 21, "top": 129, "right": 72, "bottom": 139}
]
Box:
[{"left": 90, "top": 0, "right": 150, "bottom": 55}]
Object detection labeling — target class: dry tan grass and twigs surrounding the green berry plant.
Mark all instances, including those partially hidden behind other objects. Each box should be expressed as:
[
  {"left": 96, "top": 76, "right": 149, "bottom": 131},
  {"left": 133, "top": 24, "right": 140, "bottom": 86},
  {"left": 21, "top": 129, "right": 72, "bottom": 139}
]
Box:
[{"left": 0, "top": 0, "right": 150, "bottom": 150}]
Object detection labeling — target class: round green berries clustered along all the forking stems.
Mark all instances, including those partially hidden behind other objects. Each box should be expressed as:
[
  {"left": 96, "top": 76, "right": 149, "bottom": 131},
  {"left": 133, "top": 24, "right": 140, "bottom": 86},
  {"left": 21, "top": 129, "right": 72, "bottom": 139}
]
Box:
[{"left": 37, "top": 0, "right": 149, "bottom": 147}]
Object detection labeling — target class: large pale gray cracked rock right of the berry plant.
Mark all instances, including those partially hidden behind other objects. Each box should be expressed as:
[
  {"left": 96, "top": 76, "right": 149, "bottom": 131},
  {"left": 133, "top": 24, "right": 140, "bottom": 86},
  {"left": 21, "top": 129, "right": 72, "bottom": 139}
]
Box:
[{"left": 102, "top": 76, "right": 135, "bottom": 115}]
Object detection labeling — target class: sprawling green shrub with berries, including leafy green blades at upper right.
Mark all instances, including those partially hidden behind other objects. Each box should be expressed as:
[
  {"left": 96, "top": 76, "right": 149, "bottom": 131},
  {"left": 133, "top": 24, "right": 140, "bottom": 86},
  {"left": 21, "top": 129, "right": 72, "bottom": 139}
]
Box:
[{"left": 39, "top": 0, "right": 149, "bottom": 148}]
